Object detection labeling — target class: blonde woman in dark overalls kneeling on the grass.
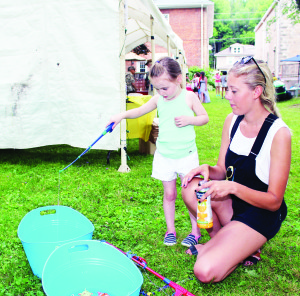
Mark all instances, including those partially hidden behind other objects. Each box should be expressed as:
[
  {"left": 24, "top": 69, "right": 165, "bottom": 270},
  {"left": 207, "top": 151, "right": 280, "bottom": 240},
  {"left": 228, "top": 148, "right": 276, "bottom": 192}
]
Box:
[{"left": 182, "top": 56, "right": 291, "bottom": 283}]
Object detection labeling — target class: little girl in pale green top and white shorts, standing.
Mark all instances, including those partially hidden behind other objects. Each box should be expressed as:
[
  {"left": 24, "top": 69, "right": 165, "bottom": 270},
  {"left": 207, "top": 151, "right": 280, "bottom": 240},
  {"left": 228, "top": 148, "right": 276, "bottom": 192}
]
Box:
[{"left": 108, "top": 57, "right": 208, "bottom": 247}]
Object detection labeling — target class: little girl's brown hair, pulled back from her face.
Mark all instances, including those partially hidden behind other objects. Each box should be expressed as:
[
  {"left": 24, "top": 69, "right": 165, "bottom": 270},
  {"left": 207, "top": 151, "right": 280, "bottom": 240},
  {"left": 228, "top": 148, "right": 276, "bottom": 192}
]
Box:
[{"left": 150, "top": 57, "right": 182, "bottom": 81}]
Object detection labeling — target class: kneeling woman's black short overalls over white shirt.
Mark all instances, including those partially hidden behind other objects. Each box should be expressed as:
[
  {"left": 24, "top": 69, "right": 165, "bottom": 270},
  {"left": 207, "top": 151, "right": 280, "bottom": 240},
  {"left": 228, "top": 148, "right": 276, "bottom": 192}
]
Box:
[{"left": 225, "top": 114, "right": 287, "bottom": 240}]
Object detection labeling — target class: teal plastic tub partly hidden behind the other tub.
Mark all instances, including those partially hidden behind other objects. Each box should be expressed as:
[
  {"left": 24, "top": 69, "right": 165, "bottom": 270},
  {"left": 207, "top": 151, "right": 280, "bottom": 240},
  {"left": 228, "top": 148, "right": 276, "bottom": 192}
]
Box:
[{"left": 18, "top": 206, "right": 94, "bottom": 278}]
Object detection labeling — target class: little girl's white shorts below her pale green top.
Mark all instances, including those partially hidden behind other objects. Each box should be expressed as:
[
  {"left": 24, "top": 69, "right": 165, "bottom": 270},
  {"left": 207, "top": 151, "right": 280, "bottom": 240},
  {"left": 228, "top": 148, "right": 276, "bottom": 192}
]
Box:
[{"left": 151, "top": 150, "right": 199, "bottom": 181}]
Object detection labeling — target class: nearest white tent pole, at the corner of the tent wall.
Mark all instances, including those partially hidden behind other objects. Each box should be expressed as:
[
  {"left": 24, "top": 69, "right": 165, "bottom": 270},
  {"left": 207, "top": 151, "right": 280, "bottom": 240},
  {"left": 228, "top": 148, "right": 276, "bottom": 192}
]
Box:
[{"left": 118, "top": 0, "right": 130, "bottom": 173}]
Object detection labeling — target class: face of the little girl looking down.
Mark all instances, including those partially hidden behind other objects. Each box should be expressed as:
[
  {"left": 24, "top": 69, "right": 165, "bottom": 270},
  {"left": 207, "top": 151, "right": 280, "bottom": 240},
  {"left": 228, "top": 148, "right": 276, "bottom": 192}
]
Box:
[{"left": 151, "top": 73, "right": 182, "bottom": 100}]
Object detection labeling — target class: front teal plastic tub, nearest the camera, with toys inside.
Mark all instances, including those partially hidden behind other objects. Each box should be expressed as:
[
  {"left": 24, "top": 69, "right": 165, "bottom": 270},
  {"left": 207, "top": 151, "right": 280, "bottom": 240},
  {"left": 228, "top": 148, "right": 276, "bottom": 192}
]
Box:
[{"left": 42, "top": 240, "right": 143, "bottom": 296}]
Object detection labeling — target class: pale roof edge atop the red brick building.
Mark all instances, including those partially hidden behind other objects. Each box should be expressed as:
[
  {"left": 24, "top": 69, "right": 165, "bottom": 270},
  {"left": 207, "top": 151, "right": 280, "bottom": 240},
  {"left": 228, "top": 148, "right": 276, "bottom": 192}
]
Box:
[{"left": 153, "top": 0, "right": 214, "bottom": 9}]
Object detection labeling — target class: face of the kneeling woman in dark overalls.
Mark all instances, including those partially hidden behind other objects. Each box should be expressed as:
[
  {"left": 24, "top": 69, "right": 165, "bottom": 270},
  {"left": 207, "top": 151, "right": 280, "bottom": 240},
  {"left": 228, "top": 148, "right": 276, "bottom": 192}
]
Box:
[{"left": 225, "top": 73, "right": 255, "bottom": 115}]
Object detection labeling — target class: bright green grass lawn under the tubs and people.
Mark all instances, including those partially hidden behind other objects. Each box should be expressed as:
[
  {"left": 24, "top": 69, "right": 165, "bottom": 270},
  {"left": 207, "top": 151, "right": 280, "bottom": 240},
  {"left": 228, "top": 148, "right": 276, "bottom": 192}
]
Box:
[{"left": 0, "top": 93, "right": 300, "bottom": 296}]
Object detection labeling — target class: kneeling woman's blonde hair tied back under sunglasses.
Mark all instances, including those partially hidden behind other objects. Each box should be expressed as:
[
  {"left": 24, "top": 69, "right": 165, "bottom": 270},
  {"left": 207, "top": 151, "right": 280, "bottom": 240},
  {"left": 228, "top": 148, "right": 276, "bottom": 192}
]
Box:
[{"left": 228, "top": 59, "right": 280, "bottom": 117}]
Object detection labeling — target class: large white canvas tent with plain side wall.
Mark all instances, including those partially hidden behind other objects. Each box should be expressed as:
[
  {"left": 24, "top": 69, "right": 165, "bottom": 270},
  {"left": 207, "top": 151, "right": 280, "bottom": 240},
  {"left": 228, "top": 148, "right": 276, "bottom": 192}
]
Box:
[{"left": 0, "top": 0, "right": 183, "bottom": 170}]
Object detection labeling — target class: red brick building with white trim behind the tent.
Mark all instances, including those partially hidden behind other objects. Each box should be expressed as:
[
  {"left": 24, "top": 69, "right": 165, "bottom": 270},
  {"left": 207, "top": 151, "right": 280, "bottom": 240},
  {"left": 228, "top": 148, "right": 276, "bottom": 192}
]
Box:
[{"left": 154, "top": 0, "right": 214, "bottom": 67}]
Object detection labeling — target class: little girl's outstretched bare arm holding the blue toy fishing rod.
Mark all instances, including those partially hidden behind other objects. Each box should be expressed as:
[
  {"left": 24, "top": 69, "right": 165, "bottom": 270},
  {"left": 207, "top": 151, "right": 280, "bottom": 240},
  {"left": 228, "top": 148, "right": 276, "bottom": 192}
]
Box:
[{"left": 107, "top": 95, "right": 159, "bottom": 129}]
